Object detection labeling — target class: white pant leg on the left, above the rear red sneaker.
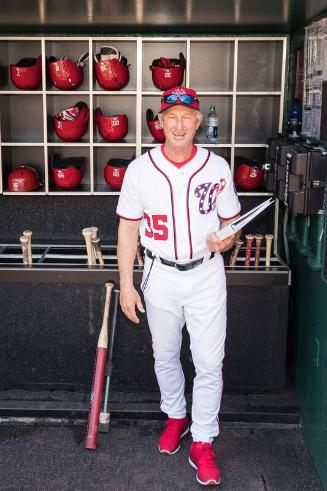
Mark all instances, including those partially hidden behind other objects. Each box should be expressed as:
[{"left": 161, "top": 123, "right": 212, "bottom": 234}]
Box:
[{"left": 144, "top": 261, "right": 186, "bottom": 418}]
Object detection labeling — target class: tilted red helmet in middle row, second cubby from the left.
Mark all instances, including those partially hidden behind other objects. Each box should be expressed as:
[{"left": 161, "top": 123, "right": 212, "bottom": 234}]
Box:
[{"left": 53, "top": 101, "right": 90, "bottom": 141}]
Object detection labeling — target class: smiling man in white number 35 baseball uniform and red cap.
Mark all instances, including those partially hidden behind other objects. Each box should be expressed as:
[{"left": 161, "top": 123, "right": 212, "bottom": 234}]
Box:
[{"left": 117, "top": 87, "right": 240, "bottom": 485}]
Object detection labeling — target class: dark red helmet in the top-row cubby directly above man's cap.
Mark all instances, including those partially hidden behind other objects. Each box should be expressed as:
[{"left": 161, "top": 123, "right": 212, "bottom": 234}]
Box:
[{"left": 150, "top": 53, "right": 186, "bottom": 90}]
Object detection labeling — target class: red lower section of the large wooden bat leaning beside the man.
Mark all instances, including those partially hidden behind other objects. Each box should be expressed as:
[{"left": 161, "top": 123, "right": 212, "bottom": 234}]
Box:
[{"left": 84, "top": 348, "right": 107, "bottom": 450}]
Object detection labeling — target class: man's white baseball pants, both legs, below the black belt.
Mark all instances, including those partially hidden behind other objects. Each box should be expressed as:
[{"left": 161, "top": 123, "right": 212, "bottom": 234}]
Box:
[{"left": 143, "top": 254, "right": 226, "bottom": 442}]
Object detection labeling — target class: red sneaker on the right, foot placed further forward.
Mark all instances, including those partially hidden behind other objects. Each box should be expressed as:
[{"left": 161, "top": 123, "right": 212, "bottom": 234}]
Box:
[{"left": 189, "top": 442, "right": 220, "bottom": 486}]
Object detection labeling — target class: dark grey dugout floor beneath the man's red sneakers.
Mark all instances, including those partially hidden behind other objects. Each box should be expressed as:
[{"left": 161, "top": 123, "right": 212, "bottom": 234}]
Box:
[{"left": 0, "top": 421, "right": 323, "bottom": 491}]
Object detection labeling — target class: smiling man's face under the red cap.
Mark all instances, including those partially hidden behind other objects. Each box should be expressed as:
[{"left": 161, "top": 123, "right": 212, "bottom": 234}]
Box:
[{"left": 159, "top": 105, "right": 202, "bottom": 149}]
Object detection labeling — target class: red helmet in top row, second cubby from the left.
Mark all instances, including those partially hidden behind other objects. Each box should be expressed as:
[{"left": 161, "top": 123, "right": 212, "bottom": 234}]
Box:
[{"left": 48, "top": 53, "right": 89, "bottom": 90}]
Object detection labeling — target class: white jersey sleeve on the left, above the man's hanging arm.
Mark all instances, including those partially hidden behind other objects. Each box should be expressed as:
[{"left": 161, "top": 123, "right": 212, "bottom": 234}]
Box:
[{"left": 116, "top": 164, "right": 143, "bottom": 220}]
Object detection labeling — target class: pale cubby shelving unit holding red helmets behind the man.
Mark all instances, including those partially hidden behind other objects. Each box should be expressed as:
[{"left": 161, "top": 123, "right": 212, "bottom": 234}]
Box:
[{"left": 0, "top": 36, "right": 287, "bottom": 200}]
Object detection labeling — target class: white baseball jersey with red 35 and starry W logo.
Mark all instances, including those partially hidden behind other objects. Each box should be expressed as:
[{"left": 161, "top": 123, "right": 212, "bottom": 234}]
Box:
[{"left": 117, "top": 147, "right": 241, "bottom": 262}]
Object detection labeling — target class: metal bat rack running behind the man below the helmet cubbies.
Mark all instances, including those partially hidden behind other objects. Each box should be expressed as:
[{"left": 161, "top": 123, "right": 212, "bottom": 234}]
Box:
[{"left": 0, "top": 242, "right": 291, "bottom": 286}]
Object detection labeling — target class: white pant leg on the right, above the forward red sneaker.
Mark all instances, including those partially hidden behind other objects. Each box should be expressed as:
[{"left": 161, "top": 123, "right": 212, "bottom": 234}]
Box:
[{"left": 184, "top": 256, "right": 226, "bottom": 442}]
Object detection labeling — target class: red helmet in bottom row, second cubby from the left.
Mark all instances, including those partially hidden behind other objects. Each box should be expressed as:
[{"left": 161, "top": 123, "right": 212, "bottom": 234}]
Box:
[{"left": 51, "top": 155, "right": 85, "bottom": 189}]
